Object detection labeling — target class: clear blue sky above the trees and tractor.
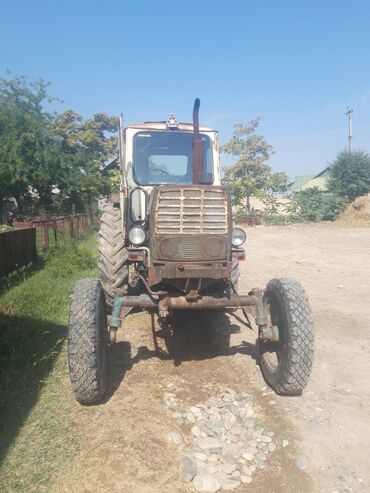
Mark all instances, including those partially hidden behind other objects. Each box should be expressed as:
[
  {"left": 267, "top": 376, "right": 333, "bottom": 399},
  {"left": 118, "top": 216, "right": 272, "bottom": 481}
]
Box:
[{"left": 0, "top": 0, "right": 370, "bottom": 178}]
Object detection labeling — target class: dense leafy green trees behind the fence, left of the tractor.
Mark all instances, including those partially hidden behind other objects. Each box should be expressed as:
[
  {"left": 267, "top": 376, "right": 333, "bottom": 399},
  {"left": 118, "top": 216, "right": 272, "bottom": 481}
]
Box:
[{"left": 0, "top": 76, "right": 117, "bottom": 210}]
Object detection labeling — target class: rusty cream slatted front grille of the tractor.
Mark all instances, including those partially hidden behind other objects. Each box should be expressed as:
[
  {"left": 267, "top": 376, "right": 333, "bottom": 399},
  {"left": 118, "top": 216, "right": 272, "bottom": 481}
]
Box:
[{"left": 155, "top": 187, "right": 228, "bottom": 235}]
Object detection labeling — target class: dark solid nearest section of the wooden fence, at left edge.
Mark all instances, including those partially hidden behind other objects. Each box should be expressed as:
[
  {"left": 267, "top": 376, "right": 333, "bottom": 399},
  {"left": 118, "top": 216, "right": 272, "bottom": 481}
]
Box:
[{"left": 0, "top": 228, "right": 37, "bottom": 277}]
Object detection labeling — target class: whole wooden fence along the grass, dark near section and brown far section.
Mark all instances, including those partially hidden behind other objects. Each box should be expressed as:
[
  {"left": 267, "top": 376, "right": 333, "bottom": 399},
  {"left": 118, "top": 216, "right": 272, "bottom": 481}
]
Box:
[{"left": 0, "top": 207, "right": 99, "bottom": 277}]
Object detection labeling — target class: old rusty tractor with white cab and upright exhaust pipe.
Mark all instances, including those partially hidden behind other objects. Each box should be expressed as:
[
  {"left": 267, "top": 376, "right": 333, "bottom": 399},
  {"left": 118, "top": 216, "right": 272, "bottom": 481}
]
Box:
[{"left": 68, "top": 99, "right": 313, "bottom": 405}]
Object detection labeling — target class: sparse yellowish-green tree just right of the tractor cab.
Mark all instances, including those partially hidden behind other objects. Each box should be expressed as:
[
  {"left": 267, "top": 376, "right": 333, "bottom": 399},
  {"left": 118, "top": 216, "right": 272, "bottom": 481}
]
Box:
[{"left": 221, "top": 118, "right": 288, "bottom": 213}]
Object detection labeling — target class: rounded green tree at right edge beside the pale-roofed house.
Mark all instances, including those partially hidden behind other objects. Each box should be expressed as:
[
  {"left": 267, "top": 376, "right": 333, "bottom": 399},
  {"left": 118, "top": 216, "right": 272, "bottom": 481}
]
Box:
[{"left": 329, "top": 151, "right": 370, "bottom": 202}]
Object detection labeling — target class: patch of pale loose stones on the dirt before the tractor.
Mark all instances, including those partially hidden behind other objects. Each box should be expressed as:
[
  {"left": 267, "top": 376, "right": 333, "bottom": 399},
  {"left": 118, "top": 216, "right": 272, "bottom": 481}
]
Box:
[{"left": 163, "top": 385, "right": 278, "bottom": 493}]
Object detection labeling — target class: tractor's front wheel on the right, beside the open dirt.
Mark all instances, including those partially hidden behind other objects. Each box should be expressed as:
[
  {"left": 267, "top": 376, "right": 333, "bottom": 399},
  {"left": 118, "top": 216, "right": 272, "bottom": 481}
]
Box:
[{"left": 259, "top": 279, "right": 314, "bottom": 395}]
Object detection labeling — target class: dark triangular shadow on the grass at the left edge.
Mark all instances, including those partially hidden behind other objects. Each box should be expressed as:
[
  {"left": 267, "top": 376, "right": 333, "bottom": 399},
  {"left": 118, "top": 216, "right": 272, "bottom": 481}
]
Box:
[{"left": 0, "top": 312, "right": 66, "bottom": 464}]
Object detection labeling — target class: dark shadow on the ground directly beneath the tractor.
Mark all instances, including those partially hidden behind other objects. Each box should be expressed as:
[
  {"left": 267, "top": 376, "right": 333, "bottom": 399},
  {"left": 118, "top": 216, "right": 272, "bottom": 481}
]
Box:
[{"left": 104, "top": 311, "right": 258, "bottom": 402}]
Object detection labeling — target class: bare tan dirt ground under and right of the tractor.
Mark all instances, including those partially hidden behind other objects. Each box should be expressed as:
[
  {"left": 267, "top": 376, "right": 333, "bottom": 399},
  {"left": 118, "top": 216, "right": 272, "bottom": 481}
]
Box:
[{"left": 54, "top": 225, "right": 370, "bottom": 493}]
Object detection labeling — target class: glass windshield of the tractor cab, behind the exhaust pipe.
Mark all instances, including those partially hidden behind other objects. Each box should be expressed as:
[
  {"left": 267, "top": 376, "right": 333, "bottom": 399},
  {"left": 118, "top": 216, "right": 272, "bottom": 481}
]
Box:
[{"left": 134, "top": 131, "right": 213, "bottom": 185}]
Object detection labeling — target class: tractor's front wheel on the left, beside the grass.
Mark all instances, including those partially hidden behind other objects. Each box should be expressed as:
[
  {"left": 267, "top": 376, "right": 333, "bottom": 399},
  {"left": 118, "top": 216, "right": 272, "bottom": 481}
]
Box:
[{"left": 68, "top": 279, "right": 108, "bottom": 404}]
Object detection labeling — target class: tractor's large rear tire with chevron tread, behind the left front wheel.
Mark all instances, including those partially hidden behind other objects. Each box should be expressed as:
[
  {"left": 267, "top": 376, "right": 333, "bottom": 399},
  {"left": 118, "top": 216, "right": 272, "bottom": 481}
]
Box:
[{"left": 99, "top": 203, "right": 128, "bottom": 312}]
